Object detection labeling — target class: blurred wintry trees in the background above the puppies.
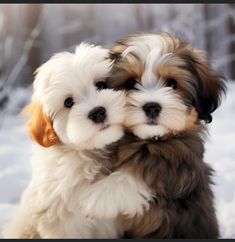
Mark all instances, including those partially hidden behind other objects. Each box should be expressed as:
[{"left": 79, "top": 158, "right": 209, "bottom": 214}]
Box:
[{"left": 0, "top": 4, "right": 235, "bottom": 113}]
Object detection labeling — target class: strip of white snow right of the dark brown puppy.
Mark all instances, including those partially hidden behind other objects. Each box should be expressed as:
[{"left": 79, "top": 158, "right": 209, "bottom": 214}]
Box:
[{"left": 205, "top": 82, "right": 235, "bottom": 238}]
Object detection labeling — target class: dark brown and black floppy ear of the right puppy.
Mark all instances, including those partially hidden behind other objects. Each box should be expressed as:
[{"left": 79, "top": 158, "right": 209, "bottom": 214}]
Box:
[{"left": 189, "top": 50, "right": 226, "bottom": 123}]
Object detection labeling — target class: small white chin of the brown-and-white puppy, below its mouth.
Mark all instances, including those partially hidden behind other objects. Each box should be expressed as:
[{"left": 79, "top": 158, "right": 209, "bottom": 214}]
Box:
[{"left": 131, "top": 124, "right": 170, "bottom": 139}]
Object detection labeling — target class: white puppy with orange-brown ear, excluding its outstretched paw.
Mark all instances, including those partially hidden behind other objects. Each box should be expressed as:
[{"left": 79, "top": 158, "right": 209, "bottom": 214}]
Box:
[{"left": 4, "top": 43, "right": 134, "bottom": 238}]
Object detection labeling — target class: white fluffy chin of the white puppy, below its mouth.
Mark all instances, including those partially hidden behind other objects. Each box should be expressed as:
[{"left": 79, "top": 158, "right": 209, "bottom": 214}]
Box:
[{"left": 79, "top": 124, "right": 124, "bottom": 150}]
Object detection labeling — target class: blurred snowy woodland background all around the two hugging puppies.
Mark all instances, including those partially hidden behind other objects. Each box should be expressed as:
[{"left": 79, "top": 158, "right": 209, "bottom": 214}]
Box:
[{"left": 0, "top": 4, "right": 235, "bottom": 238}]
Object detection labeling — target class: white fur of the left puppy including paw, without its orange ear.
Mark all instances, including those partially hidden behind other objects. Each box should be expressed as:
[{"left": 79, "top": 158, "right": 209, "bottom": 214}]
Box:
[{"left": 4, "top": 44, "right": 150, "bottom": 238}]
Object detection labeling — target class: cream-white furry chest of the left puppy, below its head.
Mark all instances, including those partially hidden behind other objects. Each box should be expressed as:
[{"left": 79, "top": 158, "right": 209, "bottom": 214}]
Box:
[{"left": 23, "top": 147, "right": 120, "bottom": 238}]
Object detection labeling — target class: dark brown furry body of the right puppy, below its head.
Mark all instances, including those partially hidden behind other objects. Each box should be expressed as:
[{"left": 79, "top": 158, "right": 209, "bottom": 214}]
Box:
[{"left": 111, "top": 128, "right": 219, "bottom": 238}]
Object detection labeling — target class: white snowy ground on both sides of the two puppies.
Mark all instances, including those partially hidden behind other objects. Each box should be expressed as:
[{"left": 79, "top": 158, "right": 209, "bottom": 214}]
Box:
[{"left": 0, "top": 82, "right": 235, "bottom": 238}]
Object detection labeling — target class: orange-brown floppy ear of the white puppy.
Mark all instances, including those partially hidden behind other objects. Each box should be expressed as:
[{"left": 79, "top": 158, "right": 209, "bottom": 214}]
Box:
[{"left": 22, "top": 102, "right": 59, "bottom": 147}]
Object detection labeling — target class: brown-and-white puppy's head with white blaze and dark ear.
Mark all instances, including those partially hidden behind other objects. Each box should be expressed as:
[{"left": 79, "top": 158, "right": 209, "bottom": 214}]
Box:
[{"left": 108, "top": 33, "right": 225, "bottom": 139}]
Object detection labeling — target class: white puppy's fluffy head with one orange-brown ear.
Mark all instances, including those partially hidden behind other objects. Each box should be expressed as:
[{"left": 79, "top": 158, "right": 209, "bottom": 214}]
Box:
[{"left": 24, "top": 43, "right": 125, "bottom": 149}]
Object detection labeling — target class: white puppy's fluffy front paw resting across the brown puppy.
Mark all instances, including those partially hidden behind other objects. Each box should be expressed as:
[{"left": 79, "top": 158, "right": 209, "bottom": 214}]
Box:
[{"left": 79, "top": 171, "right": 153, "bottom": 219}]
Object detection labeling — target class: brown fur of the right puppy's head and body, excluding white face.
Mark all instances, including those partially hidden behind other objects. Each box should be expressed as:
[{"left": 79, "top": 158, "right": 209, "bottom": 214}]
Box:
[{"left": 108, "top": 33, "right": 226, "bottom": 238}]
